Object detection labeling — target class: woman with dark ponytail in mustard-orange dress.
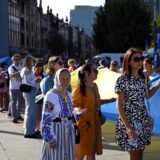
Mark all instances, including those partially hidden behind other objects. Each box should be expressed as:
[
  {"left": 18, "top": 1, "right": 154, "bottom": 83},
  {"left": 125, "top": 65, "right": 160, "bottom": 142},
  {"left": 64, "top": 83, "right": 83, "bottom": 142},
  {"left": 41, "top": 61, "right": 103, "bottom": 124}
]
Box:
[{"left": 72, "top": 63, "right": 115, "bottom": 160}]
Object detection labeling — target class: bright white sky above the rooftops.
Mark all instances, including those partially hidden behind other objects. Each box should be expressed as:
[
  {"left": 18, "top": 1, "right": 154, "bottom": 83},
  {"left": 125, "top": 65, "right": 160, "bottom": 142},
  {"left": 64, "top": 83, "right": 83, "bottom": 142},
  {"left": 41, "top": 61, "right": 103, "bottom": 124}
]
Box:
[{"left": 38, "top": 0, "right": 105, "bottom": 19}]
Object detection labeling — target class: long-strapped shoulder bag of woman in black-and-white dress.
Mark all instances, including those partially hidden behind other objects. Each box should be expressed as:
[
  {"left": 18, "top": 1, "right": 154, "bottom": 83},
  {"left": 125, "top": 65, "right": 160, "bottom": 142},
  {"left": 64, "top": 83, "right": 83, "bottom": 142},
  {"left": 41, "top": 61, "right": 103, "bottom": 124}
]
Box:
[{"left": 145, "top": 75, "right": 154, "bottom": 131}]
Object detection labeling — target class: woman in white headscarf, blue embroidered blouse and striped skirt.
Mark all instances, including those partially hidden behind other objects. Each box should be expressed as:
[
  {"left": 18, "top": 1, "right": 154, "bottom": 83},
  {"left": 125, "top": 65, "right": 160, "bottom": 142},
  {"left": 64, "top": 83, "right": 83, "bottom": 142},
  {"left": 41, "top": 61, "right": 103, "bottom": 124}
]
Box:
[{"left": 40, "top": 68, "right": 75, "bottom": 160}]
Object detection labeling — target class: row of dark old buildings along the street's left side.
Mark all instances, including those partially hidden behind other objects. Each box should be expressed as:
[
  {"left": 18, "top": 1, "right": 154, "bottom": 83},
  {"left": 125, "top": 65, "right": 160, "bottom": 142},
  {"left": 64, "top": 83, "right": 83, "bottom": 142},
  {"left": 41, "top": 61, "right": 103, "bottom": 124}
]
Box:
[{"left": 0, "top": 0, "right": 92, "bottom": 58}]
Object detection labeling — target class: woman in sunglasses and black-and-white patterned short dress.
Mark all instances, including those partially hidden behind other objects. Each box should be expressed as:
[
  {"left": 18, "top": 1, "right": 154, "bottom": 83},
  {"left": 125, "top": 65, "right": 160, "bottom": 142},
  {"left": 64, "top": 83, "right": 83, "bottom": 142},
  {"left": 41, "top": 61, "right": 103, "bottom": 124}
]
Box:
[{"left": 115, "top": 48, "right": 160, "bottom": 160}]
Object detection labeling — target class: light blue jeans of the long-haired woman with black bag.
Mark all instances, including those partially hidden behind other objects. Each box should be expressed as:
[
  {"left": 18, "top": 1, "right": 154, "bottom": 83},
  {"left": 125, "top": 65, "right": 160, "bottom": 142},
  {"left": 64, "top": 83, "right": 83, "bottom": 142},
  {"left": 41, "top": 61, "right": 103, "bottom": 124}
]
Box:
[{"left": 23, "top": 87, "right": 37, "bottom": 135}]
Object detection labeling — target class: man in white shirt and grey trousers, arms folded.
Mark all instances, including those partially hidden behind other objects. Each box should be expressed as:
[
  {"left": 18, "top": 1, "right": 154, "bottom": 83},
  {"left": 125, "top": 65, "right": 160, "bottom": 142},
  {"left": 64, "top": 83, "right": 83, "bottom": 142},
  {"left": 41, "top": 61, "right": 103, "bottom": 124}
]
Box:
[{"left": 8, "top": 54, "right": 25, "bottom": 123}]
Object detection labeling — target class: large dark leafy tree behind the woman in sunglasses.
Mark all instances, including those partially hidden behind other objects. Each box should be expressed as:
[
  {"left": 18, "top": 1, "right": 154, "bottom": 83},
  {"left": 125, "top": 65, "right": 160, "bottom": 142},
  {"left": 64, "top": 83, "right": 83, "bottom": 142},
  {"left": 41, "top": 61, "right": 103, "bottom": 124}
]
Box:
[{"left": 93, "top": 0, "right": 151, "bottom": 53}]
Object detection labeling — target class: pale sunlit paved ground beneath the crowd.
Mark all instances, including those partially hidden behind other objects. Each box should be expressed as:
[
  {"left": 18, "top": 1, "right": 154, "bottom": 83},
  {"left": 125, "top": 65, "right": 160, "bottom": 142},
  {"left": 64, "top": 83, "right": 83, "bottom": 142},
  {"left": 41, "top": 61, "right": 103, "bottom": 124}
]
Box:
[{"left": 0, "top": 113, "right": 136, "bottom": 160}]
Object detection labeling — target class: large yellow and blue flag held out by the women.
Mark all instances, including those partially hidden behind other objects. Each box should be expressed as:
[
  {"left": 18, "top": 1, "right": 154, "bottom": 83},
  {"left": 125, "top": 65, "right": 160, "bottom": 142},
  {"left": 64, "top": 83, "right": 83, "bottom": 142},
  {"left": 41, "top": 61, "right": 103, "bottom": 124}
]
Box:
[{"left": 71, "top": 68, "right": 160, "bottom": 134}]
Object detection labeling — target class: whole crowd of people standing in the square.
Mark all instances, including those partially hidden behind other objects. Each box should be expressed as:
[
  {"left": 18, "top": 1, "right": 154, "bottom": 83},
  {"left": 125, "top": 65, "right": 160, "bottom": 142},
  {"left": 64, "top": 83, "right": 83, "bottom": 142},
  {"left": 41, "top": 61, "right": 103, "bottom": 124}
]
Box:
[{"left": 0, "top": 48, "right": 160, "bottom": 160}]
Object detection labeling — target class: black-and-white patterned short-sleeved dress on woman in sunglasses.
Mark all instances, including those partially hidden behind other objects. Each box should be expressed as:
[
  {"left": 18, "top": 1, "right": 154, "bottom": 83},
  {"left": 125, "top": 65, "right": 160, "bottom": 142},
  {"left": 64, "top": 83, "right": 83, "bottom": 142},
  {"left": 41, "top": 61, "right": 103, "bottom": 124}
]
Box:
[{"left": 115, "top": 75, "right": 151, "bottom": 151}]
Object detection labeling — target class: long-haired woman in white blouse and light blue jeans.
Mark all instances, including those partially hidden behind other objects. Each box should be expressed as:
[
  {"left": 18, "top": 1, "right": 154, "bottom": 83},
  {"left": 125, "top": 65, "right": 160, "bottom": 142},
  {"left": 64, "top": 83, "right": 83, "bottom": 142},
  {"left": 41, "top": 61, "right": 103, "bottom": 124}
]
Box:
[{"left": 20, "top": 55, "right": 41, "bottom": 138}]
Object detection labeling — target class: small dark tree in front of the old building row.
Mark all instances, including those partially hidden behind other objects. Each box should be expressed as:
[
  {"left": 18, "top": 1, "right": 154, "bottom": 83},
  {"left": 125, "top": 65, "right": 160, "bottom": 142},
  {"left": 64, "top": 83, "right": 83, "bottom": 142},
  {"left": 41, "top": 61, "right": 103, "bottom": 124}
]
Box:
[{"left": 48, "top": 32, "right": 66, "bottom": 55}]
